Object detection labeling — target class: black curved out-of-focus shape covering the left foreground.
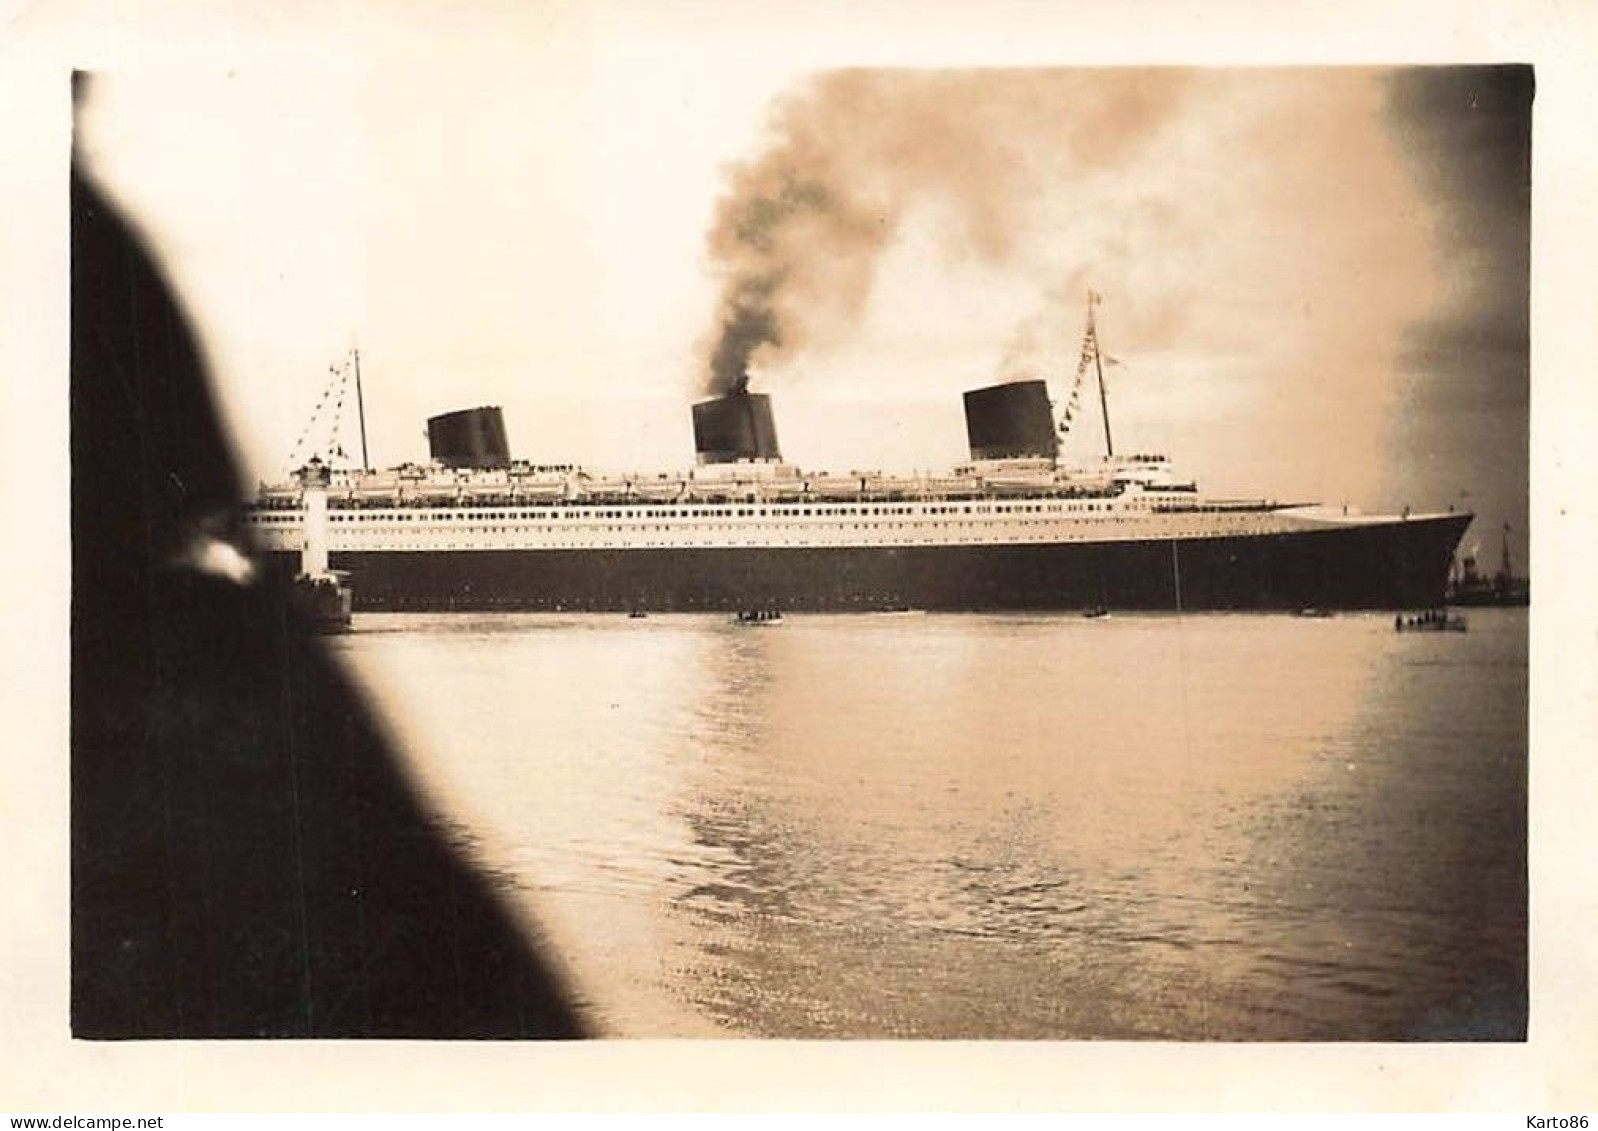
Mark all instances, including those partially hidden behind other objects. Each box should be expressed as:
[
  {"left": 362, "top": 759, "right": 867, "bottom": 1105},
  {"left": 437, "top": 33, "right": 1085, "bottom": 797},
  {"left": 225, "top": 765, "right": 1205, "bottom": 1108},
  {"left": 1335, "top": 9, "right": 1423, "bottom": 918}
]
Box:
[{"left": 70, "top": 103, "right": 583, "bottom": 1038}]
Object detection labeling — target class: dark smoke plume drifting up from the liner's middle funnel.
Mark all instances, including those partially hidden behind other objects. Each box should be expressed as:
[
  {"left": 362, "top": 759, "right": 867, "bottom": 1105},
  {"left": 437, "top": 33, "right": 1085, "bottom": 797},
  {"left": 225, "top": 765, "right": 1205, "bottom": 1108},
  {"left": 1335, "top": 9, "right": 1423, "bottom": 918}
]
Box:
[{"left": 710, "top": 70, "right": 1189, "bottom": 395}]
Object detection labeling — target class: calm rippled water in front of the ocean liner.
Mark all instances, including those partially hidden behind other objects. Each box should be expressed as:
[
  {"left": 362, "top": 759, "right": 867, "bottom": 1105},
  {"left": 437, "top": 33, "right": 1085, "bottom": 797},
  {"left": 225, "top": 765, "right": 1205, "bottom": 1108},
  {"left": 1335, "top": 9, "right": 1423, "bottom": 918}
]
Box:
[{"left": 336, "top": 610, "right": 1526, "bottom": 1040}]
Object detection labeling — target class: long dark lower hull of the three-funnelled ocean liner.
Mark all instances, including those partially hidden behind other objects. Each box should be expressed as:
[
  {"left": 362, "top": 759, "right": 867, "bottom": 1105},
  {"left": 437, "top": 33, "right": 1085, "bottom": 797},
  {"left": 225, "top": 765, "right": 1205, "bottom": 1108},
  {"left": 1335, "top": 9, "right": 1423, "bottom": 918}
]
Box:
[{"left": 265, "top": 514, "right": 1470, "bottom": 612}]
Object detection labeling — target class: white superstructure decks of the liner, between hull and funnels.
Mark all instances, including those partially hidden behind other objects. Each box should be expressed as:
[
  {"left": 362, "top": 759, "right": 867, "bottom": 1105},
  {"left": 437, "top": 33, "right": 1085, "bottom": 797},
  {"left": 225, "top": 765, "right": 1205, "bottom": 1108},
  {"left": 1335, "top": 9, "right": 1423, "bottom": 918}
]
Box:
[{"left": 248, "top": 455, "right": 1425, "bottom": 553}]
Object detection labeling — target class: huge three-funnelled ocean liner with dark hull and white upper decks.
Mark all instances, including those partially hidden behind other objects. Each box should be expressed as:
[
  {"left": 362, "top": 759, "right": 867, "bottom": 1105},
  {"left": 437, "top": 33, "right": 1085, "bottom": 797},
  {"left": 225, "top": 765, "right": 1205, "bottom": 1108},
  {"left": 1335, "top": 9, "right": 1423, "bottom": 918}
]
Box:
[{"left": 246, "top": 305, "right": 1470, "bottom": 612}]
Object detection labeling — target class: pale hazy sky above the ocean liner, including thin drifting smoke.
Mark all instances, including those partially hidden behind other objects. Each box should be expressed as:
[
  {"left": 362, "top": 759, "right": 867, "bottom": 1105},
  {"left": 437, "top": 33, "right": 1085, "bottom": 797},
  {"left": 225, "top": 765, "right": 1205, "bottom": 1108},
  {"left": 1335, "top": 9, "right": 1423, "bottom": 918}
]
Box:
[{"left": 78, "top": 23, "right": 1531, "bottom": 554}]
